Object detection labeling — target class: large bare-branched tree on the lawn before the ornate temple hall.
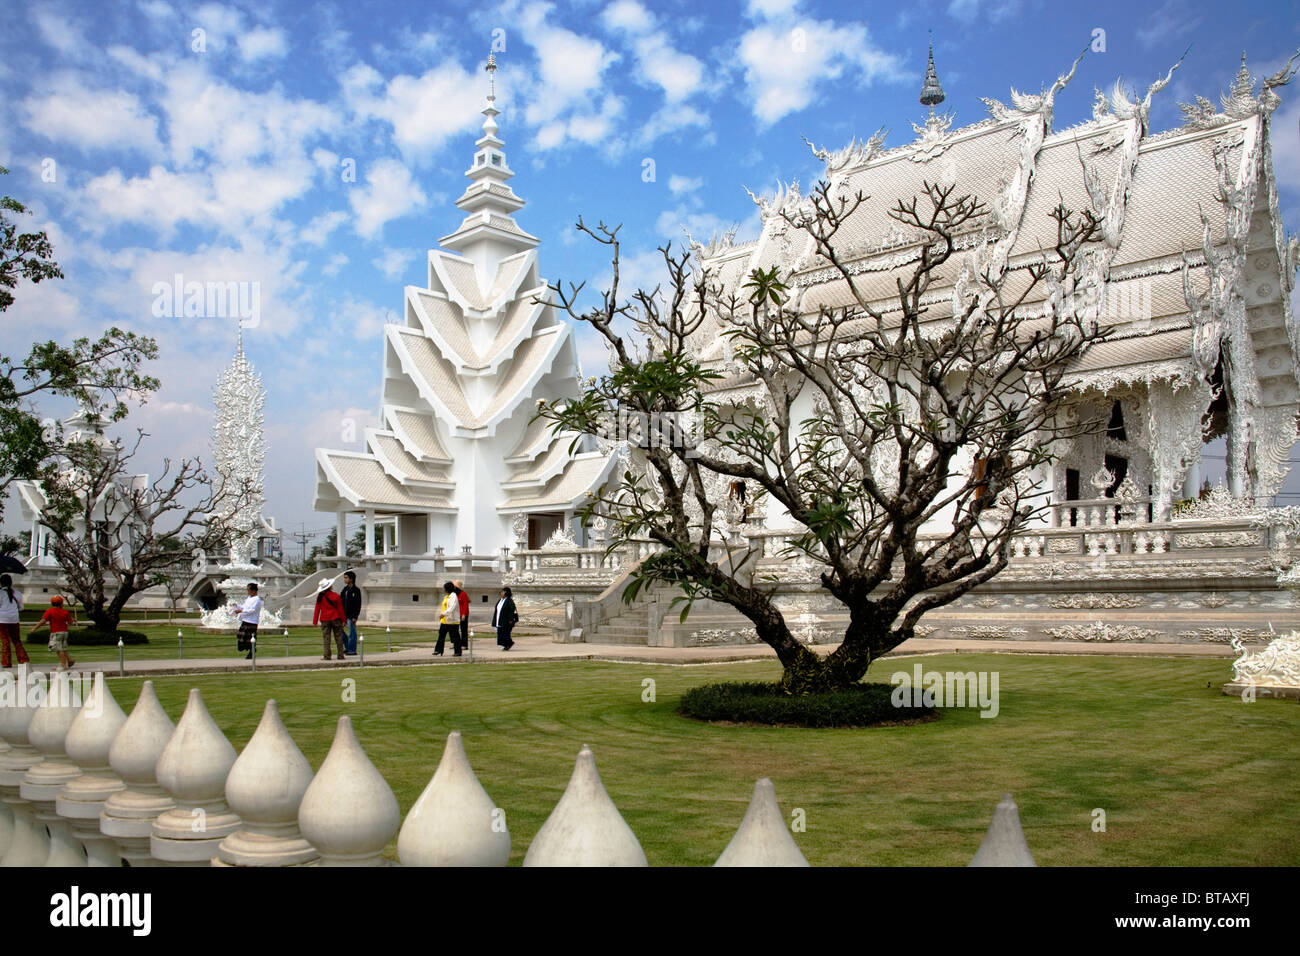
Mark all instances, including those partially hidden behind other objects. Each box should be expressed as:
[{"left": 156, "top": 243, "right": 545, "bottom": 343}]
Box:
[{"left": 538, "top": 182, "right": 1106, "bottom": 693}]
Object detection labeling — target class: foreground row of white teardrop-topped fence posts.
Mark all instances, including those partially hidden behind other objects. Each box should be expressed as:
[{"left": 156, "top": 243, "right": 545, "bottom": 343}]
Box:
[{"left": 0, "top": 667, "right": 1034, "bottom": 866}]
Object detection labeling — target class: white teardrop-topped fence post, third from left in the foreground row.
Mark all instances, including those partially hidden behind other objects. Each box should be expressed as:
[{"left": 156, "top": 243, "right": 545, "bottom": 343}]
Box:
[{"left": 55, "top": 671, "right": 126, "bottom": 866}]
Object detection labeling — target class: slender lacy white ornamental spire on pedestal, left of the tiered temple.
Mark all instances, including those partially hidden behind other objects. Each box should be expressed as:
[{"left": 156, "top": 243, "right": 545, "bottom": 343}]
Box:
[{"left": 200, "top": 326, "right": 281, "bottom": 631}]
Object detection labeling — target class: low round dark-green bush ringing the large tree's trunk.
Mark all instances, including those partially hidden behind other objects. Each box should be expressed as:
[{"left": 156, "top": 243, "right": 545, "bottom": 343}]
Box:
[{"left": 677, "top": 682, "right": 939, "bottom": 727}]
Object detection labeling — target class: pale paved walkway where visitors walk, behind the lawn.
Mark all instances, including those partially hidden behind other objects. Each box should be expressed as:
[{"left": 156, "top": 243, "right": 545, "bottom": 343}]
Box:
[{"left": 25, "top": 637, "right": 1235, "bottom": 676}]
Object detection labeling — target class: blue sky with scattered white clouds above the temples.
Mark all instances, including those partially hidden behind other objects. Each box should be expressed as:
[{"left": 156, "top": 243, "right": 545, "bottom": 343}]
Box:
[{"left": 0, "top": 0, "right": 1300, "bottom": 548}]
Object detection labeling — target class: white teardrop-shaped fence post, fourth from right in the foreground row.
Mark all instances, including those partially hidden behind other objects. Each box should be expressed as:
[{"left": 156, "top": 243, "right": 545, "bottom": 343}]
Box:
[{"left": 398, "top": 730, "right": 510, "bottom": 866}]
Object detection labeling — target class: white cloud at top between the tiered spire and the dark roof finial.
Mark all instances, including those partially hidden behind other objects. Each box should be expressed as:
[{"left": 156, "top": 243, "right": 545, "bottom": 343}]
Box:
[{"left": 737, "top": 20, "right": 904, "bottom": 126}]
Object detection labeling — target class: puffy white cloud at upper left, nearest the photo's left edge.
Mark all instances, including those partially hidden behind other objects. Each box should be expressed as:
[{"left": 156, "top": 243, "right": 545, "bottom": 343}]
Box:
[{"left": 22, "top": 73, "right": 163, "bottom": 156}]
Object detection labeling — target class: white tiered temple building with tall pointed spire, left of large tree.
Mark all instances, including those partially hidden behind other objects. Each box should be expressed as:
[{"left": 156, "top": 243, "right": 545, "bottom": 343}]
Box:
[{"left": 315, "top": 57, "right": 611, "bottom": 571}]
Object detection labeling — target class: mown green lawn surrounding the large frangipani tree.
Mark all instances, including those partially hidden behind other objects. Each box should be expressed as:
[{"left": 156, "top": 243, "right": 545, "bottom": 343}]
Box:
[{"left": 101, "top": 654, "right": 1300, "bottom": 866}]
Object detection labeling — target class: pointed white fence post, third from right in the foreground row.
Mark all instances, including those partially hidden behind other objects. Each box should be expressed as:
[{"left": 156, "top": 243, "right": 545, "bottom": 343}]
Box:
[{"left": 524, "top": 744, "right": 649, "bottom": 866}]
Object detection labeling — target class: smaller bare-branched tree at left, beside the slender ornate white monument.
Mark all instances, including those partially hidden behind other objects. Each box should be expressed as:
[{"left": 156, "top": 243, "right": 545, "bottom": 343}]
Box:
[{"left": 40, "top": 432, "right": 248, "bottom": 632}]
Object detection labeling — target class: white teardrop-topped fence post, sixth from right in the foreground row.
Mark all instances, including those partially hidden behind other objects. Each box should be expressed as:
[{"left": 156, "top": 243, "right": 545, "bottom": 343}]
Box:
[{"left": 212, "top": 700, "right": 320, "bottom": 866}]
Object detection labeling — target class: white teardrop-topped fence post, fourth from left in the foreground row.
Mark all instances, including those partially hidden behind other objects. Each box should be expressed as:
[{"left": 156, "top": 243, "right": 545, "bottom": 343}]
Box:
[{"left": 99, "top": 680, "right": 176, "bottom": 866}]
